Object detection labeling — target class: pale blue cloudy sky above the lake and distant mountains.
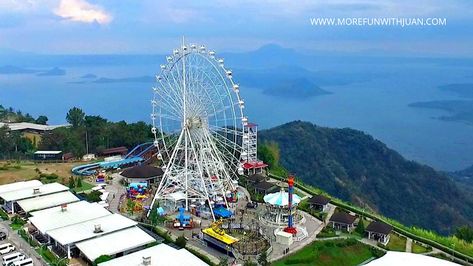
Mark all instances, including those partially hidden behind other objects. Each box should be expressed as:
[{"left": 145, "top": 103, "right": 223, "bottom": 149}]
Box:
[{"left": 0, "top": 0, "right": 473, "bottom": 57}]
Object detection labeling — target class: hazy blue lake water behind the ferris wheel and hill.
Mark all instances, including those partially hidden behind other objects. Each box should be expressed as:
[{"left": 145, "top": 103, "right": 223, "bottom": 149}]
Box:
[{"left": 0, "top": 51, "right": 473, "bottom": 171}]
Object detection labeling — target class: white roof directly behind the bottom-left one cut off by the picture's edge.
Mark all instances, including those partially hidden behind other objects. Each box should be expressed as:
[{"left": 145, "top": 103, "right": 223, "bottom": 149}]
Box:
[{"left": 76, "top": 226, "right": 155, "bottom": 261}]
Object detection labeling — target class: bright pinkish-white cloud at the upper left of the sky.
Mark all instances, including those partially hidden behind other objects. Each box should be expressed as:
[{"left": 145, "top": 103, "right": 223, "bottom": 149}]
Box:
[{"left": 54, "top": 0, "right": 112, "bottom": 24}]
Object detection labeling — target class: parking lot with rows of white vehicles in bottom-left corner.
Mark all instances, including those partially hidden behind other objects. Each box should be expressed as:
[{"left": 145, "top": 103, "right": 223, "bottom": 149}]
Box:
[{"left": 0, "top": 221, "right": 47, "bottom": 266}]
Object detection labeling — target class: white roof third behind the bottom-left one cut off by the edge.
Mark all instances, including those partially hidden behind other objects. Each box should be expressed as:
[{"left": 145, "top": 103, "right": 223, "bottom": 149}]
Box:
[{"left": 29, "top": 201, "right": 110, "bottom": 234}]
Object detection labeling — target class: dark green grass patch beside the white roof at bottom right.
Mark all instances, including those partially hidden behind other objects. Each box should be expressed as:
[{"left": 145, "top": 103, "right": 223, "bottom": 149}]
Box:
[{"left": 272, "top": 239, "right": 384, "bottom": 266}]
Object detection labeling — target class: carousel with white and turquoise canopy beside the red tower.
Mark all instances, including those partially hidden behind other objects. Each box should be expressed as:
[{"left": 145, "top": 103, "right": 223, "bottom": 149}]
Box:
[{"left": 260, "top": 188, "right": 302, "bottom": 227}]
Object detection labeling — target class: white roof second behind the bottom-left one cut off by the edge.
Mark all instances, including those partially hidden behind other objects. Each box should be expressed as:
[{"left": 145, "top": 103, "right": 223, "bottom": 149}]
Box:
[{"left": 47, "top": 214, "right": 137, "bottom": 245}]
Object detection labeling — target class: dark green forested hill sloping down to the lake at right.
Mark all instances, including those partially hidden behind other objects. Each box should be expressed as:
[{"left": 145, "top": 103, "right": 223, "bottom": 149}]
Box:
[{"left": 259, "top": 121, "right": 473, "bottom": 234}]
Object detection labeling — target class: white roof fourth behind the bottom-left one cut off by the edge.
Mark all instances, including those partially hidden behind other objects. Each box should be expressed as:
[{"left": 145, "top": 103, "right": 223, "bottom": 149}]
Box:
[{"left": 17, "top": 191, "right": 79, "bottom": 212}]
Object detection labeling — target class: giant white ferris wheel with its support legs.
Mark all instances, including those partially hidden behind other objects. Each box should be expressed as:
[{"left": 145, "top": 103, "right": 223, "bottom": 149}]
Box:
[{"left": 151, "top": 42, "right": 247, "bottom": 218}]
